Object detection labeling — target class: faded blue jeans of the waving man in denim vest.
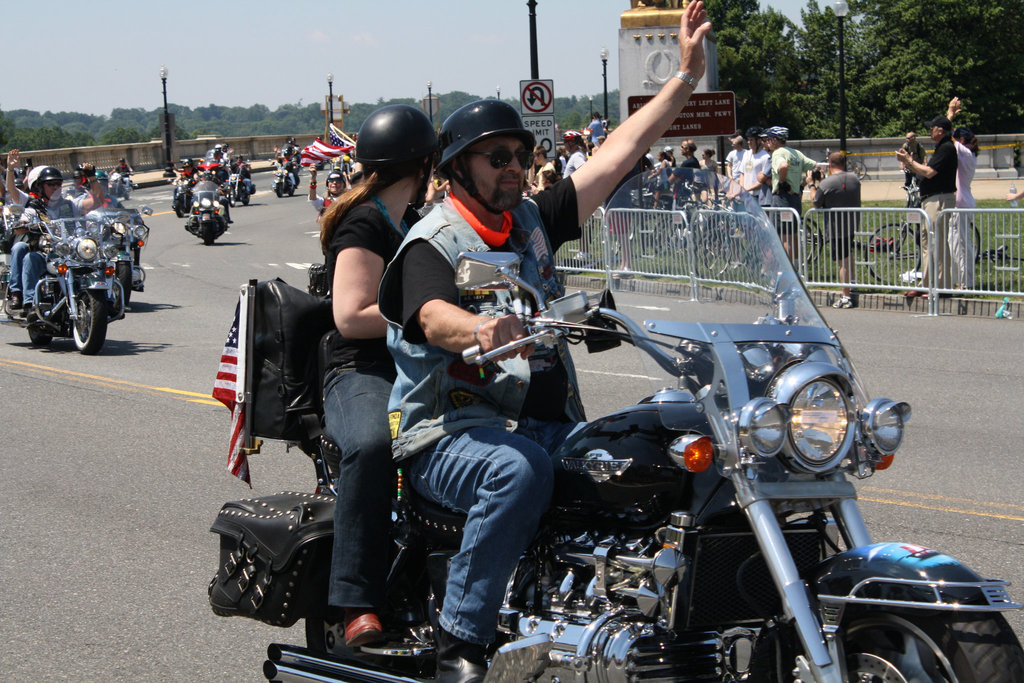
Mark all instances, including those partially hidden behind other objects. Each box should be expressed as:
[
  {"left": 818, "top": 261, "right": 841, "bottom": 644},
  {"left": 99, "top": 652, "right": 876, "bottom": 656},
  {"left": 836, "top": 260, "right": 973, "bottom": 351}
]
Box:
[{"left": 408, "top": 420, "right": 580, "bottom": 645}]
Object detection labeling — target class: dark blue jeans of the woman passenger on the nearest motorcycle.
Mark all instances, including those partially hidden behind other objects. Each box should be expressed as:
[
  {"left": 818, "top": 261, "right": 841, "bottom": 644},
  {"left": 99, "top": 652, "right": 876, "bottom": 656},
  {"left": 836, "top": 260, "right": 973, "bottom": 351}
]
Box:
[{"left": 324, "top": 359, "right": 395, "bottom": 609}]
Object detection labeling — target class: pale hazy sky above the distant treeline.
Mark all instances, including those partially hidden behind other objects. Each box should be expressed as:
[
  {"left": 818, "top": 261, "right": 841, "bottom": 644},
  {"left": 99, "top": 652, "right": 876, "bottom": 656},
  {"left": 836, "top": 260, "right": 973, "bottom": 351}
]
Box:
[{"left": 6, "top": 0, "right": 806, "bottom": 115}]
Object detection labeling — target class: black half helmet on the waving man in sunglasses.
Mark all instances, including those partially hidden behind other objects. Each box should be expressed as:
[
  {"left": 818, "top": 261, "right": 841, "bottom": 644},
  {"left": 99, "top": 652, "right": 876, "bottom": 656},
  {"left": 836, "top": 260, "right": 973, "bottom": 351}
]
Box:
[{"left": 437, "top": 99, "right": 537, "bottom": 178}]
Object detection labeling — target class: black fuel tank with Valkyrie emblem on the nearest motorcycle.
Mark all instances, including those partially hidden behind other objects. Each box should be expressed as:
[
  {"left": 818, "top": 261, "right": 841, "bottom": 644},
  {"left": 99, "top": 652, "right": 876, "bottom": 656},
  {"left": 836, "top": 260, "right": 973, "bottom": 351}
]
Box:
[{"left": 552, "top": 392, "right": 728, "bottom": 530}]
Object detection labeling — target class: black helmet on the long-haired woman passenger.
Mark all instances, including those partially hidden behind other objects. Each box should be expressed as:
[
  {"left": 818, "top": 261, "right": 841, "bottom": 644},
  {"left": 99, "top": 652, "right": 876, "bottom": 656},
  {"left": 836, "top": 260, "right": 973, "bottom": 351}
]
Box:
[{"left": 355, "top": 104, "right": 437, "bottom": 166}]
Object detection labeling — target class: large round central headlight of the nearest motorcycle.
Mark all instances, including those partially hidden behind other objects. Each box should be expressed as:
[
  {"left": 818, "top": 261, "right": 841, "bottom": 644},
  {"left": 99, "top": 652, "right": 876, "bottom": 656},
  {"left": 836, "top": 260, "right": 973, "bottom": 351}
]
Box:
[{"left": 790, "top": 380, "right": 849, "bottom": 470}]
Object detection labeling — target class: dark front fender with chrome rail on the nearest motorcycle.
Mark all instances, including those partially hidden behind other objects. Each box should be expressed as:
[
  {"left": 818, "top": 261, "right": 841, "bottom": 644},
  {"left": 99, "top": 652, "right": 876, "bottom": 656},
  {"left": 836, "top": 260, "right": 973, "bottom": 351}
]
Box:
[{"left": 811, "top": 543, "right": 1021, "bottom": 611}]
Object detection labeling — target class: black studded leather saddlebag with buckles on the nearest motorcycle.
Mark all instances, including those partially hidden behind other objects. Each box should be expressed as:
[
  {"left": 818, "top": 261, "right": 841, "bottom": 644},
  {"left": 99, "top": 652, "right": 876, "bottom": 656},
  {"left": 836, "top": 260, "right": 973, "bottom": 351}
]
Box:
[{"left": 209, "top": 493, "right": 335, "bottom": 627}]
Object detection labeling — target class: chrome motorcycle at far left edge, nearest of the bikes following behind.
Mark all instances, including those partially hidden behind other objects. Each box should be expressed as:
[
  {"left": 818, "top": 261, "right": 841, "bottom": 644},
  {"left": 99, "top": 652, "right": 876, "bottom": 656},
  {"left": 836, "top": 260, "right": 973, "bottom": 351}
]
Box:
[{"left": 5, "top": 207, "right": 124, "bottom": 355}]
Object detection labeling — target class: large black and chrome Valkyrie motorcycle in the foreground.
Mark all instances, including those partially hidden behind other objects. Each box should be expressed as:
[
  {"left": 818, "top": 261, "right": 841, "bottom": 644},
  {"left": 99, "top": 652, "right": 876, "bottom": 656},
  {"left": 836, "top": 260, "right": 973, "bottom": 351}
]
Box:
[{"left": 210, "top": 167, "right": 1024, "bottom": 683}]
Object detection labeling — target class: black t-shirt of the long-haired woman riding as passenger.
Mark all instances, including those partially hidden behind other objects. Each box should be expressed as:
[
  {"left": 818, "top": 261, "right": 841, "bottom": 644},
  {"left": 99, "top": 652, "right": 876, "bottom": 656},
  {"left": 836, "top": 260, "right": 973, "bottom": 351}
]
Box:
[{"left": 326, "top": 206, "right": 419, "bottom": 369}]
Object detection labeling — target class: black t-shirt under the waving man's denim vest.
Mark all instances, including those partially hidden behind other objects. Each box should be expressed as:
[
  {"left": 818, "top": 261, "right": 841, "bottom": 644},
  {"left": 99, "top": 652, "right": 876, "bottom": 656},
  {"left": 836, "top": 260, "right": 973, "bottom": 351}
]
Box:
[{"left": 401, "top": 177, "right": 580, "bottom": 420}]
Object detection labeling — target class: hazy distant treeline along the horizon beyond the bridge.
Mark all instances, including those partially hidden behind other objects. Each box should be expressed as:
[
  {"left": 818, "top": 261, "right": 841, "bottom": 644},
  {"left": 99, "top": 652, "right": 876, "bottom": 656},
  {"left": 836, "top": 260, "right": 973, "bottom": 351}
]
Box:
[{"left": 0, "top": 91, "right": 618, "bottom": 152}]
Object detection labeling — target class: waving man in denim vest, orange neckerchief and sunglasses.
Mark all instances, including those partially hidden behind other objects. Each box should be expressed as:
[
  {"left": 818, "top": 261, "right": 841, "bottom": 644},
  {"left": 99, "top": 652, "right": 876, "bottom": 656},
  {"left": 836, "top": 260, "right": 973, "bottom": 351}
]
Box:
[{"left": 378, "top": 0, "right": 711, "bottom": 683}]
